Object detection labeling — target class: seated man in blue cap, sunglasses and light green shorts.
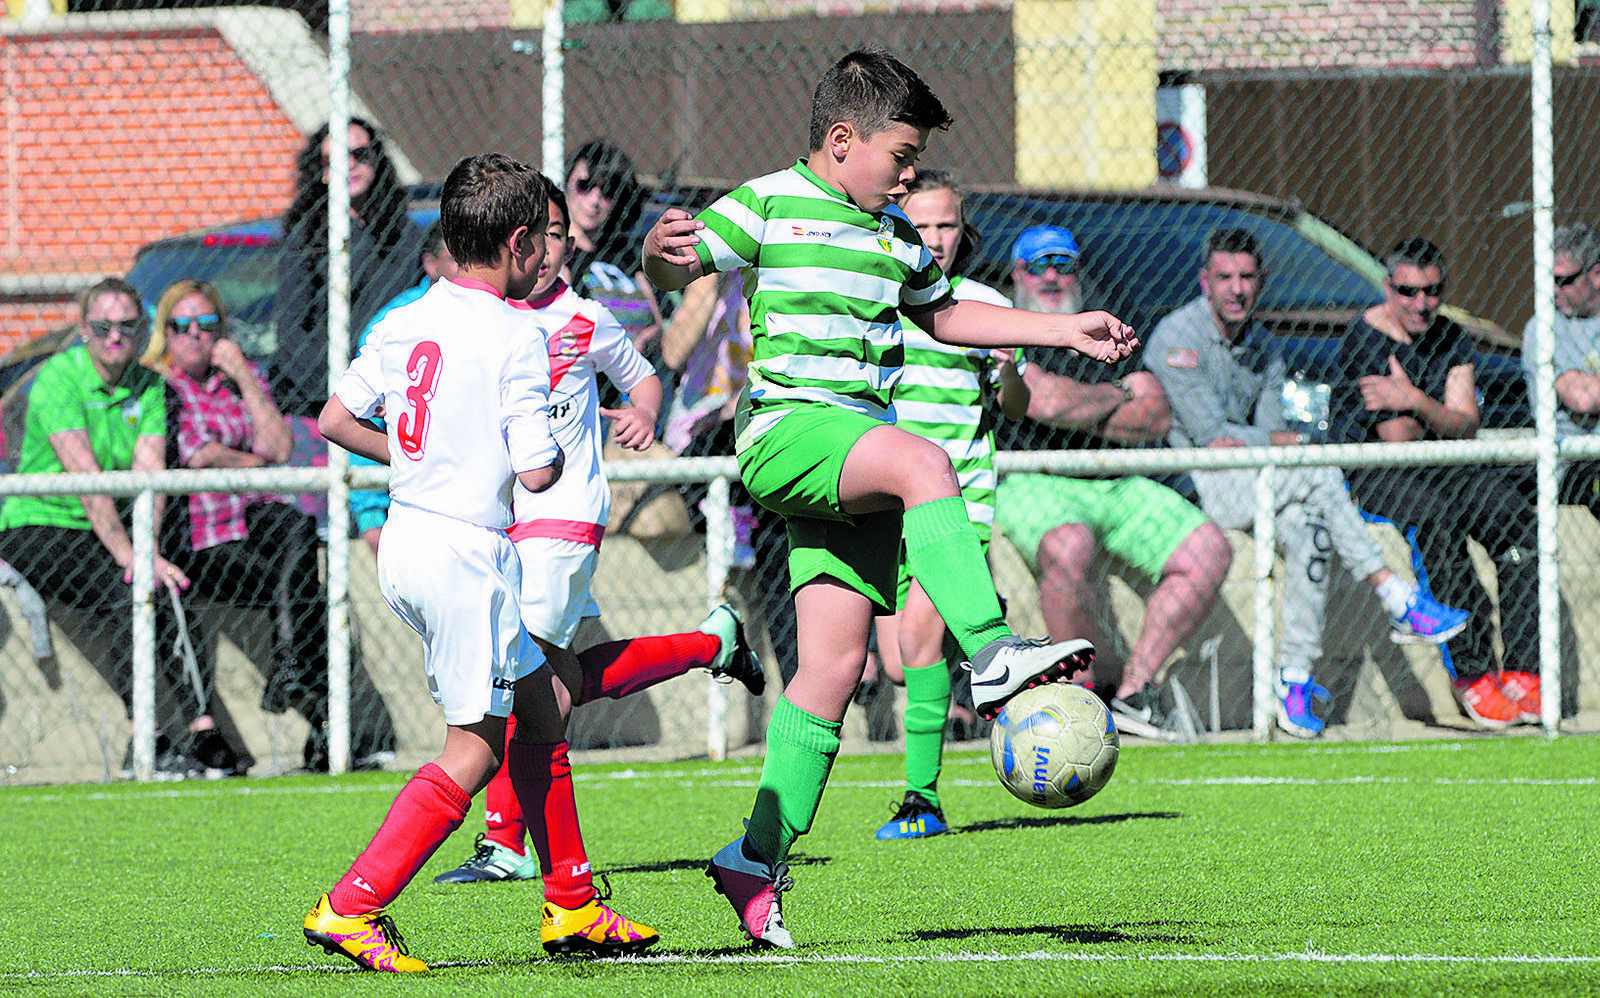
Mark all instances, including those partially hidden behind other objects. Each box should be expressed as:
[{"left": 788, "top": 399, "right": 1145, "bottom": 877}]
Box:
[{"left": 995, "top": 226, "right": 1234, "bottom": 737}]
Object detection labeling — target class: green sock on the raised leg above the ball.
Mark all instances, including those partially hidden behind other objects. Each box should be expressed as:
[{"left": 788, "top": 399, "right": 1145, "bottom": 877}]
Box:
[{"left": 904, "top": 496, "right": 1011, "bottom": 659}]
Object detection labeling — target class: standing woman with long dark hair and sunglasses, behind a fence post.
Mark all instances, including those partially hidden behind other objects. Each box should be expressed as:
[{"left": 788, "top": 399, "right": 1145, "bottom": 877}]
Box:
[{"left": 272, "top": 118, "right": 422, "bottom": 419}]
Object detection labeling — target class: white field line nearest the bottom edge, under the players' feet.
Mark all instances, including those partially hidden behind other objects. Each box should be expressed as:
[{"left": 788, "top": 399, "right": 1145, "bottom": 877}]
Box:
[{"left": 0, "top": 950, "right": 1600, "bottom": 982}]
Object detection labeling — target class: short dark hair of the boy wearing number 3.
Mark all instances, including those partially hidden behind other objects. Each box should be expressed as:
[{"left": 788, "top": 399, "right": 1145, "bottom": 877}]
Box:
[{"left": 438, "top": 152, "right": 550, "bottom": 267}]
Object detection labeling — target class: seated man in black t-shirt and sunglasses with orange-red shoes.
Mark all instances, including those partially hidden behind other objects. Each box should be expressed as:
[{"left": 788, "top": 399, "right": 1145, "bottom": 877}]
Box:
[{"left": 1333, "top": 237, "right": 1539, "bottom": 728}]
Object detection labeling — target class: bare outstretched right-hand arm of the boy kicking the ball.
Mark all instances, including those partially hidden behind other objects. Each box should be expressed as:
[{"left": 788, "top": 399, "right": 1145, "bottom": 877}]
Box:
[{"left": 907, "top": 299, "right": 1139, "bottom": 363}]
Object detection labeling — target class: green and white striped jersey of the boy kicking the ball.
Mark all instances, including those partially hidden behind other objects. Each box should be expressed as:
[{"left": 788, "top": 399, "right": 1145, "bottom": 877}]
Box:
[{"left": 694, "top": 160, "right": 950, "bottom": 449}]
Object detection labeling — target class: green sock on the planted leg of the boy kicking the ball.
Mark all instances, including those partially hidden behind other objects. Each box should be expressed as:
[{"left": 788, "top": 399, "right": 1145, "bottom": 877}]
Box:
[{"left": 746, "top": 697, "right": 843, "bottom": 864}]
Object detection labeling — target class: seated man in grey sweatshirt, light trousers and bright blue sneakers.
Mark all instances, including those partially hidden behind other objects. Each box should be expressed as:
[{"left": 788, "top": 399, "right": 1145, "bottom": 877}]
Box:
[{"left": 1144, "top": 229, "right": 1467, "bottom": 737}]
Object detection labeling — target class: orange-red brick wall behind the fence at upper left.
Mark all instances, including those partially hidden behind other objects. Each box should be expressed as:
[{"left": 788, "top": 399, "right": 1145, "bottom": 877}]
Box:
[{"left": 0, "top": 29, "right": 302, "bottom": 344}]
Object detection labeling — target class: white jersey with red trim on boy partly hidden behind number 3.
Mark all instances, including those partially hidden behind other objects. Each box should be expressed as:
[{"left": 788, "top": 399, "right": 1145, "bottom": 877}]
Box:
[{"left": 510, "top": 283, "right": 654, "bottom": 544}]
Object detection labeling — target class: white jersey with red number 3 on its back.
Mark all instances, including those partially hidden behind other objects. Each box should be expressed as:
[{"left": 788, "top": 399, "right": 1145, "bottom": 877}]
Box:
[{"left": 336, "top": 280, "right": 557, "bottom": 529}]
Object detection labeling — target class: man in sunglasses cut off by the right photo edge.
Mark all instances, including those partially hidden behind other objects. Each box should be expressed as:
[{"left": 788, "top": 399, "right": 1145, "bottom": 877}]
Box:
[{"left": 1522, "top": 224, "right": 1600, "bottom": 517}]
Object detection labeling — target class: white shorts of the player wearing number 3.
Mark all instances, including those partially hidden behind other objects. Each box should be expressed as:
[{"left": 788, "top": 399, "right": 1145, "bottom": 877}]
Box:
[{"left": 378, "top": 502, "right": 544, "bottom": 725}]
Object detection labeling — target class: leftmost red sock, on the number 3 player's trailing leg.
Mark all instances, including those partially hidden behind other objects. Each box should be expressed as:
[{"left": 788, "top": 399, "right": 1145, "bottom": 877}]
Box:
[{"left": 328, "top": 763, "right": 472, "bottom": 918}]
